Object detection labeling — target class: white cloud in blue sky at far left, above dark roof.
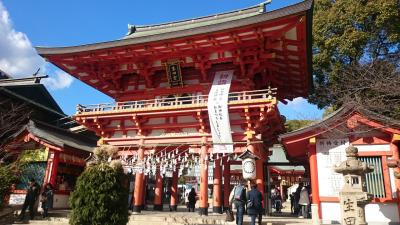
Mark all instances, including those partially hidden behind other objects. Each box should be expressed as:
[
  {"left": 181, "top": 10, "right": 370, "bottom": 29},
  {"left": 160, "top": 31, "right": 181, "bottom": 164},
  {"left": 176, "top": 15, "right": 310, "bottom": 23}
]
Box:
[{"left": 0, "top": 1, "right": 73, "bottom": 90}]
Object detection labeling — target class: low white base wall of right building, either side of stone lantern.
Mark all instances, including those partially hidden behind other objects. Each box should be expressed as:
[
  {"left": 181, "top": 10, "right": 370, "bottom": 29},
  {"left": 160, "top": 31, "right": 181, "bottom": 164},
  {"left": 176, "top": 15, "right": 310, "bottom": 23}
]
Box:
[{"left": 321, "top": 202, "right": 400, "bottom": 225}]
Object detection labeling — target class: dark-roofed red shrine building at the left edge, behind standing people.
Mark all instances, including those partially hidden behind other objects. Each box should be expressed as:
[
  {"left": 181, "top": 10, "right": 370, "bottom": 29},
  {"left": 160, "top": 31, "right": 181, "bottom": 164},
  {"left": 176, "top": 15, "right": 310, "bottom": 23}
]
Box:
[{"left": 0, "top": 76, "right": 98, "bottom": 208}]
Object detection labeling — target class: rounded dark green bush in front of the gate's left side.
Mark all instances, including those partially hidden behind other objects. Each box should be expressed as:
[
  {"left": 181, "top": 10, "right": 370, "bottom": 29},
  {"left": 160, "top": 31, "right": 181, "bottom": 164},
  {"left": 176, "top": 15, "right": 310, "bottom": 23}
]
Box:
[{"left": 70, "top": 145, "right": 128, "bottom": 225}]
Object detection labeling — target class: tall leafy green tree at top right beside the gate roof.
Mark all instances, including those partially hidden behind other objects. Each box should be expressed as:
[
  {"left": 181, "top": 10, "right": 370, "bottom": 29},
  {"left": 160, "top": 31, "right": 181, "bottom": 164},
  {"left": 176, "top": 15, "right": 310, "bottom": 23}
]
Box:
[{"left": 309, "top": 0, "right": 400, "bottom": 108}]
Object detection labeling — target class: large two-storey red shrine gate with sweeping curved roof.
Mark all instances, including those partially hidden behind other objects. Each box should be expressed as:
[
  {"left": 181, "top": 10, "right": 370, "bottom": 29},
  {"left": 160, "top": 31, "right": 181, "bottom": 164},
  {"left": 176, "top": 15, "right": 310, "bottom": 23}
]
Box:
[{"left": 37, "top": 0, "right": 312, "bottom": 214}]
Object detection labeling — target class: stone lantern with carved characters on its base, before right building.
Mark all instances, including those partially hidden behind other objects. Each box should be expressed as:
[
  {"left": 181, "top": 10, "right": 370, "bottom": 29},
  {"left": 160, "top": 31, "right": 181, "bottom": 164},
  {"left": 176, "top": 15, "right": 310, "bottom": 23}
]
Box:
[{"left": 334, "top": 145, "right": 374, "bottom": 225}]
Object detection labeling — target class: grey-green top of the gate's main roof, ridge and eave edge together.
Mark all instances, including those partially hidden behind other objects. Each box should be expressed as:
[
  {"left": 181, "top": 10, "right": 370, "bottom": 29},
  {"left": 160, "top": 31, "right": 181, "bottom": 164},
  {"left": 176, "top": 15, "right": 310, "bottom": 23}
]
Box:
[{"left": 36, "top": 0, "right": 313, "bottom": 54}]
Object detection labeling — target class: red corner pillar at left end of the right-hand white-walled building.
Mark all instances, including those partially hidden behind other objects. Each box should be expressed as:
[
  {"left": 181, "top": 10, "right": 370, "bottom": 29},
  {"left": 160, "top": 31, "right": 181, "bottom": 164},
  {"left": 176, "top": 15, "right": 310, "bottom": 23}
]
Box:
[{"left": 308, "top": 138, "right": 321, "bottom": 220}]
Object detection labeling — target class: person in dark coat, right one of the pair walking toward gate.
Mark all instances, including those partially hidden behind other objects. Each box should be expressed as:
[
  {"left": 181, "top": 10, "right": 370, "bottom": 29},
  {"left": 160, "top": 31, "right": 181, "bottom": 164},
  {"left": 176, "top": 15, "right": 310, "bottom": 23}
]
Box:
[{"left": 247, "top": 181, "right": 263, "bottom": 225}]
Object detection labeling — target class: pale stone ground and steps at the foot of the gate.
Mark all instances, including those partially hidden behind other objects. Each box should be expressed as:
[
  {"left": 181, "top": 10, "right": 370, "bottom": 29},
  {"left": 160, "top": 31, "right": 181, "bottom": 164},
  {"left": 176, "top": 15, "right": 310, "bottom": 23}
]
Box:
[{"left": 0, "top": 201, "right": 311, "bottom": 225}]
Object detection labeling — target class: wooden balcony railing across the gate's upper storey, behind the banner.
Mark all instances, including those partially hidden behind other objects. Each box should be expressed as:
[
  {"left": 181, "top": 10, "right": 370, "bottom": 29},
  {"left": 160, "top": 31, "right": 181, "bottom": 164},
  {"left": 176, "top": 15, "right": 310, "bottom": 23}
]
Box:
[{"left": 76, "top": 88, "right": 276, "bottom": 115}]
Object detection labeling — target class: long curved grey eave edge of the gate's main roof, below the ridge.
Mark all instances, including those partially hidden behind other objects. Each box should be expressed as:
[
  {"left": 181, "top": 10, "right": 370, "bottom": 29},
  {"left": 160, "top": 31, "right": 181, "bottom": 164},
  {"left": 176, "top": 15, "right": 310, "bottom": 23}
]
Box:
[{"left": 36, "top": 0, "right": 313, "bottom": 56}]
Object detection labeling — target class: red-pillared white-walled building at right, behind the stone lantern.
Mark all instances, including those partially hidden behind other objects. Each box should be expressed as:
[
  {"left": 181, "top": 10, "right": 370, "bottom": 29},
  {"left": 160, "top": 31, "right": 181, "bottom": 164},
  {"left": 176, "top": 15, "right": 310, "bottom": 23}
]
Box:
[{"left": 279, "top": 105, "right": 400, "bottom": 224}]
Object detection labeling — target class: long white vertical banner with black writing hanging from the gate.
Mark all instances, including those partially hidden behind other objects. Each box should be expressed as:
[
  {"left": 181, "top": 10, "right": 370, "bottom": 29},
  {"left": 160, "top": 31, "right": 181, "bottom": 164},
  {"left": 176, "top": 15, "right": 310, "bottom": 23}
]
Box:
[{"left": 207, "top": 70, "right": 233, "bottom": 153}]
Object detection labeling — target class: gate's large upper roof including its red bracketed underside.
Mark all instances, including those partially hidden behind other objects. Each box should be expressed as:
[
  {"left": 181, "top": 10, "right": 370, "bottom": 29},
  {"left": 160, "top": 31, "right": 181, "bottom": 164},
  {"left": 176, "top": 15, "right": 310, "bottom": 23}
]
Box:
[{"left": 37, "top": 0, "right": 313, "bottom": 101}]
